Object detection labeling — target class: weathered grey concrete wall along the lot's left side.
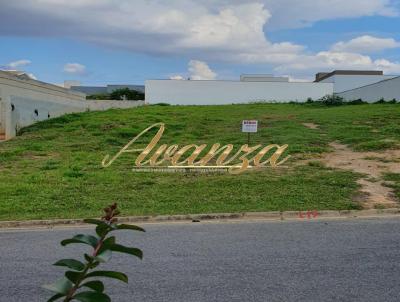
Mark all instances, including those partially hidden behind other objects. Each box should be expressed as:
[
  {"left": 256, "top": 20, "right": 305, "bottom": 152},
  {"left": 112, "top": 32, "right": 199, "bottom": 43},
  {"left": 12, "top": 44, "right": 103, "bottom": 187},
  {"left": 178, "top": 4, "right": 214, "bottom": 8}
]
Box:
[{"left": 0, "top": 71, "right": 144, "bottom": 139}]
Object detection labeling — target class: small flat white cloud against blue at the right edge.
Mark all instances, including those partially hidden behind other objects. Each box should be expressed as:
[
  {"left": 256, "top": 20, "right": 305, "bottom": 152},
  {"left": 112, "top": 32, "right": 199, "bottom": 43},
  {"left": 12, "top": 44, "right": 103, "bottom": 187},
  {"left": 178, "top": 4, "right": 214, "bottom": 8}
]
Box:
[{"left": 332, "top": 35, "right": 400, "bottom": 53}]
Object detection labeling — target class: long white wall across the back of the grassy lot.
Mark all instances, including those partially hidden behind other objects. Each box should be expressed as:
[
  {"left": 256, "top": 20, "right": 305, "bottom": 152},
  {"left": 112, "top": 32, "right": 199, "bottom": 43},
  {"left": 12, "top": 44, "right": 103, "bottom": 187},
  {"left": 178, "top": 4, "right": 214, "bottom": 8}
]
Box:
[{"left": 146, "top": 80, "right": 333, "bottom": 105}]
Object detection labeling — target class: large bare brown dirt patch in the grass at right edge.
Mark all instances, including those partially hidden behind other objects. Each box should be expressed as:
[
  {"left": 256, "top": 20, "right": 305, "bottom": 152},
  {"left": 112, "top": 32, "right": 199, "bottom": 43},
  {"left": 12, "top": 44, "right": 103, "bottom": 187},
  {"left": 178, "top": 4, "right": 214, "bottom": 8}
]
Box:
[{"left": 321, "top": 143, "right": 400, "bottom": 208}]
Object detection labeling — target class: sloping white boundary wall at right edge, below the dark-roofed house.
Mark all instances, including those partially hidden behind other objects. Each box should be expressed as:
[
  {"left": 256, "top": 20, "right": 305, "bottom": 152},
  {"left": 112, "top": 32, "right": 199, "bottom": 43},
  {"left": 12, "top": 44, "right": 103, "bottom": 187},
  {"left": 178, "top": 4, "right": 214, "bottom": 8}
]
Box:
[{"left": 338, "top": 77, "right": 400, "bottom": 103}]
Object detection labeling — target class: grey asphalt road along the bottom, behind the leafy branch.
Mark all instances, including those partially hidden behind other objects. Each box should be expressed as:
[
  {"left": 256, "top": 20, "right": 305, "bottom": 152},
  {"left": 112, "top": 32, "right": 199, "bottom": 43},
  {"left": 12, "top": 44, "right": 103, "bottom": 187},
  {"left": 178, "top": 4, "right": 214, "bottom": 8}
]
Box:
[{"left": 0, "top": 218, "right": 400, "bottom": 302}]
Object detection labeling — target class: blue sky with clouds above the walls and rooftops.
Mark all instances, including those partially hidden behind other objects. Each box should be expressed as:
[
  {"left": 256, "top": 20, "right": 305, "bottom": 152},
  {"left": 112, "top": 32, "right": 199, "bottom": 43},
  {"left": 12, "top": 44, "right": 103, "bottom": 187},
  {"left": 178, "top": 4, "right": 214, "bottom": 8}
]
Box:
[{"left": 0, "top": 0, "right": 400, "bottom": 86}]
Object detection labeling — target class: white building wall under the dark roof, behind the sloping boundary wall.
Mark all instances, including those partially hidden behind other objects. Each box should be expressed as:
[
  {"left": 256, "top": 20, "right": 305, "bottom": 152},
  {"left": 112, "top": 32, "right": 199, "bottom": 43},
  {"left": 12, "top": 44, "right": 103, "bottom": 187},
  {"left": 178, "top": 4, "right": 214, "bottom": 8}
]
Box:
[{"left": 319, "top": 74, "right": 396, "bottom": 93}]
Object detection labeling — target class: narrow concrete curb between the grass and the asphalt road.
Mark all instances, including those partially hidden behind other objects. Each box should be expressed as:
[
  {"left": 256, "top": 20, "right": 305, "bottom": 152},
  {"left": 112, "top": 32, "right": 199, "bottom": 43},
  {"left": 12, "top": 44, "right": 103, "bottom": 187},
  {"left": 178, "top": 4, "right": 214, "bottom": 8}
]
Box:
[{"left": 0, "top": 208, "right": 400, "bottom": 229}]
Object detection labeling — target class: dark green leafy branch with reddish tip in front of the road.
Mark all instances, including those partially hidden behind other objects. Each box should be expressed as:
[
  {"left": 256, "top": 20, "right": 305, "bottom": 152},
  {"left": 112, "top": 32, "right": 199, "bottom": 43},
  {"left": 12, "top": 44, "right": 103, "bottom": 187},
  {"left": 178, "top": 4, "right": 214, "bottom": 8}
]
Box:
[{"left": 43, "top": 203, "right": 144, "bottom": 302}]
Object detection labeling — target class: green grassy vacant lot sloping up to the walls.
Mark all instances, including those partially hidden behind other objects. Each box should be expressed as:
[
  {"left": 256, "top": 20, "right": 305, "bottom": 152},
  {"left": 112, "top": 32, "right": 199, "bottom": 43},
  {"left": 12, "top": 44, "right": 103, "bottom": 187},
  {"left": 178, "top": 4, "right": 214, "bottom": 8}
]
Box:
[{"left": 0, "top": 104, "right": 400, "bottom": 220}]
